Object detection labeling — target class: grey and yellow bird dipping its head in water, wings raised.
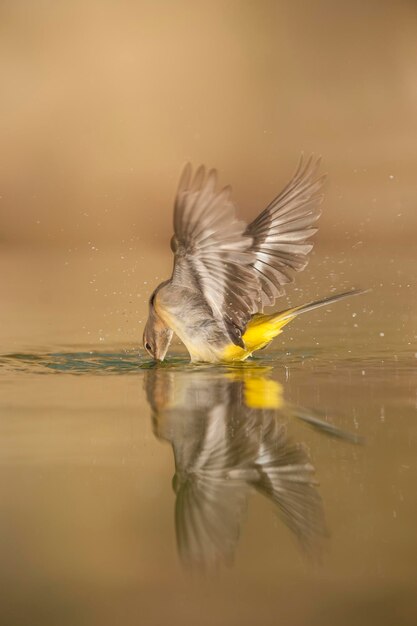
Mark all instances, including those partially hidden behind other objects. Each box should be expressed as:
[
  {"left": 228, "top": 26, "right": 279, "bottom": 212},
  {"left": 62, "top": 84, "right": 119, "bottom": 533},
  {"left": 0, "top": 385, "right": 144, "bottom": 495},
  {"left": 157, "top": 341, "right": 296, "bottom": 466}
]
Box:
[{"left": 143, "top": 155, "right": 362, "bottom": 363}]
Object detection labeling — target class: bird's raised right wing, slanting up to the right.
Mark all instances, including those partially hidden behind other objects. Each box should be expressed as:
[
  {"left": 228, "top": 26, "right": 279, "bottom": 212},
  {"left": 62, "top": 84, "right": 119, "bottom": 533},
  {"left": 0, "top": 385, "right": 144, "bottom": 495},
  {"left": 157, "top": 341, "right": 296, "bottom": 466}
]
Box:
[{"left": 245, "top": 156, "right": 325, "bottom": 309}]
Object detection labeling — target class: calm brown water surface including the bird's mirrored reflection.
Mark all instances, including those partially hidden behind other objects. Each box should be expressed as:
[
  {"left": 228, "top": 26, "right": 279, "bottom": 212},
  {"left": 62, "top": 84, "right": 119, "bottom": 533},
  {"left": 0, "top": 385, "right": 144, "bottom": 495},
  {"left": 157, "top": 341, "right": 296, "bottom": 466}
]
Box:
[{"left": 0, "top": 247, "right": 417, "bottom": 626}]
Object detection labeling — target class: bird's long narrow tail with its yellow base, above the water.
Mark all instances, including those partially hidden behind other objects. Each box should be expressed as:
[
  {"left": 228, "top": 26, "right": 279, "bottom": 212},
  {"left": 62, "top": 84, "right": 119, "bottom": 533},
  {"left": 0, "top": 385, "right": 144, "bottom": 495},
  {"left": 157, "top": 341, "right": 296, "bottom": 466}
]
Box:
[{"left": 243, "top": 289, "right": 365, "bottom": 351}]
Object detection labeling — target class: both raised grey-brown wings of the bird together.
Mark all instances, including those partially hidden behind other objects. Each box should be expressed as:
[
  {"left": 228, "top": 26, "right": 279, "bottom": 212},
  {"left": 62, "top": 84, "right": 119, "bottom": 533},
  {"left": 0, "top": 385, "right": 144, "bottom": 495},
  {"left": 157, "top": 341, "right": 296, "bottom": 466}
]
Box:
[{"left": 171, "top": 157, "right": 324, "bottom": 334}]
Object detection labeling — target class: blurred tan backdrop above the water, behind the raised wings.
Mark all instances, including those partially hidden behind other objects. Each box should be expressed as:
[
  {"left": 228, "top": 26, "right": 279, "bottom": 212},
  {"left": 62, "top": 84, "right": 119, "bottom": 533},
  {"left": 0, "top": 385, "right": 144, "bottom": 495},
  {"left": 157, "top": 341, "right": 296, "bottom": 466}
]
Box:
[{"left": 0, "top": 0, "right": 417, "bottom": 249}]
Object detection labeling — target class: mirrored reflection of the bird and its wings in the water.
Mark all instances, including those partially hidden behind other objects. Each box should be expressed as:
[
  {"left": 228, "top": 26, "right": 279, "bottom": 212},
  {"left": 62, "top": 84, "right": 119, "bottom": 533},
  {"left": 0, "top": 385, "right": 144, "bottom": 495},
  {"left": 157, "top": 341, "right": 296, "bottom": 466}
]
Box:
[{"left": 145, "top": 366, "right": 326, "bottom": 570}]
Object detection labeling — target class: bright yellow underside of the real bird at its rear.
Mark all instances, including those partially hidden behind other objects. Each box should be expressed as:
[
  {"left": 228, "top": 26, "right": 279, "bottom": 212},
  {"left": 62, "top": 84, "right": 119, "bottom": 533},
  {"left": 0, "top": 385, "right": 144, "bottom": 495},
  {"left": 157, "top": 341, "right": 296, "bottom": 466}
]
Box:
[{"left": 221, "top": 309, "right": 296, "bottom": 362}]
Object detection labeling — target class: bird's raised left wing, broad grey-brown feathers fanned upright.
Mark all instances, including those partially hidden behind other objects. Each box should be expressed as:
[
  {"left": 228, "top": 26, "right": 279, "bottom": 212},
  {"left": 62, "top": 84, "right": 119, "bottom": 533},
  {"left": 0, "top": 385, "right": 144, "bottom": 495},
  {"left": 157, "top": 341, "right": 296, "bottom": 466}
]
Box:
[{"left": 171, "top": 164, "right": 261, "bottom": 331}]
